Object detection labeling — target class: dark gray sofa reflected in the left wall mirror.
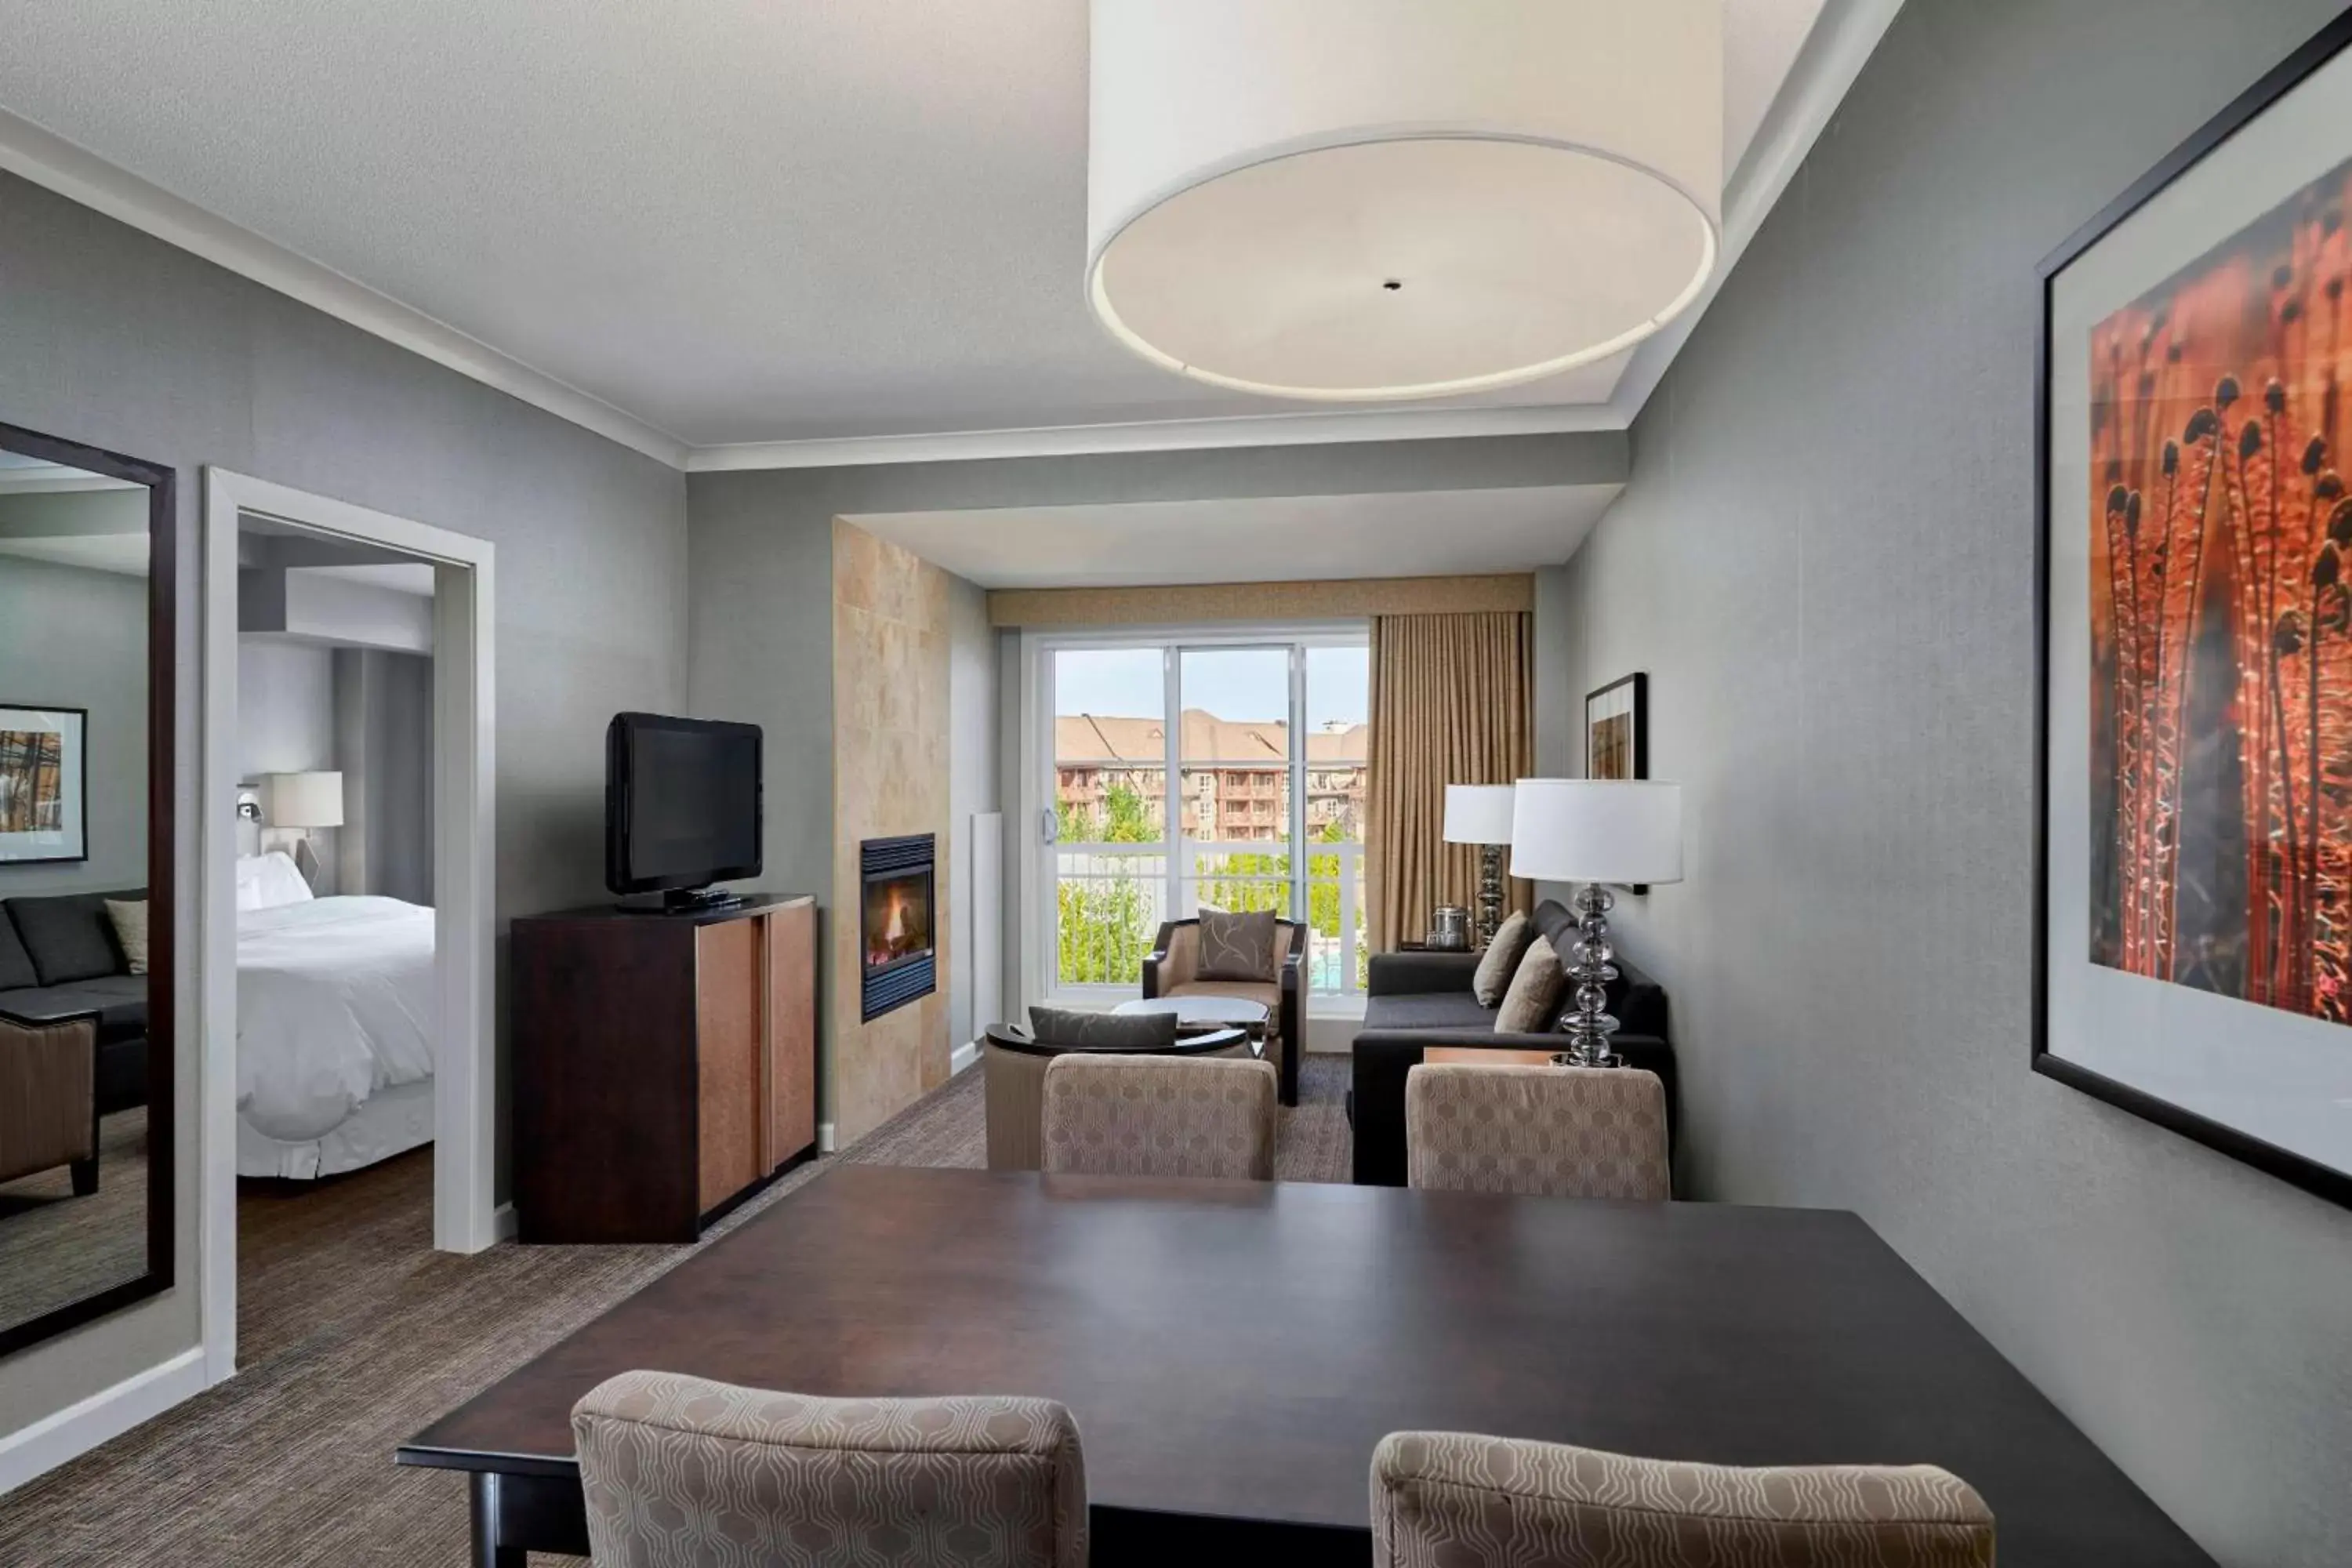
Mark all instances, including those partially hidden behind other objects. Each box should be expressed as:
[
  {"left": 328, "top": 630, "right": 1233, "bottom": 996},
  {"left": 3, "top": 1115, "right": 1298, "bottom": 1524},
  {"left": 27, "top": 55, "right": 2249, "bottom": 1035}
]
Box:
[{"left": 0, "top": 888, "right": 148, "bottom": 1116}]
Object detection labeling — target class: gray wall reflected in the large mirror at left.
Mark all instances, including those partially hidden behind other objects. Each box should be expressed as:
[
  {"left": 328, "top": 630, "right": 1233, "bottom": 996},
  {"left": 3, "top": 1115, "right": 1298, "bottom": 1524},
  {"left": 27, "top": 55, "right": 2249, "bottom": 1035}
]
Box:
[{"left": 0, "top": 554, "right": 148, "bottom": 898}]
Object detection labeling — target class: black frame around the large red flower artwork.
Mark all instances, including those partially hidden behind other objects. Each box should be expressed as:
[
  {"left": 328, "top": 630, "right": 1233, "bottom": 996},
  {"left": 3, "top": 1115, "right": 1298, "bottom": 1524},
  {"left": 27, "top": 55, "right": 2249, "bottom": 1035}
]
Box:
[{"left": 2030, "top": 9, "right": 2352, "bottom": 1208}]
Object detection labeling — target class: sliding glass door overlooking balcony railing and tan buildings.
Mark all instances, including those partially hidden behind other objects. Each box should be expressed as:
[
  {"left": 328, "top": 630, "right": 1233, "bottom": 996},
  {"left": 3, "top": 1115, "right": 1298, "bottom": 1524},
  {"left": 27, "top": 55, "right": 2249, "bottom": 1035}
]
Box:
[{"left": 1042, "top": 633, "right": 1369, "bottom": 999}]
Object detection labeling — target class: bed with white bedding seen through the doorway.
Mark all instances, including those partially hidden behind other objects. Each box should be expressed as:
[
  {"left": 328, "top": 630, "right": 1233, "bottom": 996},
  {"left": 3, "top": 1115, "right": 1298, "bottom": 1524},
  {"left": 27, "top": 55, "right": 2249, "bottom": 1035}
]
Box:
[{"left": 238, "top": 853, "right": 437, "bottom": 1180}]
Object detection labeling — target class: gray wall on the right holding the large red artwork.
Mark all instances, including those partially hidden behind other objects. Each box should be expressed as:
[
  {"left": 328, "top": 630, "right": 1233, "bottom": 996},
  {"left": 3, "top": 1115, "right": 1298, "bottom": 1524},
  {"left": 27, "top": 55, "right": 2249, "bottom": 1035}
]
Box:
[{"left": 1562, "top": 0, "right": 2352, "bottom": 1568}]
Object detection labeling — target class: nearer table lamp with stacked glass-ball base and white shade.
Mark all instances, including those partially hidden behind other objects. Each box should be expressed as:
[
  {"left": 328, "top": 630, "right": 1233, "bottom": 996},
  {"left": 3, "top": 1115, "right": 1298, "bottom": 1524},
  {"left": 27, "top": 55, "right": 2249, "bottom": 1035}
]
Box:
[{"left": 1510, "top": 779, "right": 1682, "bottom": 1067}]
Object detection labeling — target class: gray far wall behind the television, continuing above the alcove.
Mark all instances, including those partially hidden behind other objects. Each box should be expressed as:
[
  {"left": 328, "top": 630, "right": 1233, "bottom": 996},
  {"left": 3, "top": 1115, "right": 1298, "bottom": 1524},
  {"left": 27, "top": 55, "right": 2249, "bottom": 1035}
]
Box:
[{"left": 687, "top": 433, "right": 1628, "bottom": 1062}]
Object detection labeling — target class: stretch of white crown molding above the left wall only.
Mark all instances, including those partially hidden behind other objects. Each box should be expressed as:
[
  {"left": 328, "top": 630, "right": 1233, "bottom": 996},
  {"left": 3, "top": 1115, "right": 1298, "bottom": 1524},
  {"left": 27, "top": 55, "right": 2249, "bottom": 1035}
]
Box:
[{"left": 0, "top": 108, "right": 687, "bottom": 468}]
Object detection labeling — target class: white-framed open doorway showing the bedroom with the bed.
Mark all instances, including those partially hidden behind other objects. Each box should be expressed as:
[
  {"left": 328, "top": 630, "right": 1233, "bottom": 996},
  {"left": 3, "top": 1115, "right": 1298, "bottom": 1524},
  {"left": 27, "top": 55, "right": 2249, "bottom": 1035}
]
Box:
[{"left": 200, "top": 470, "right": 499, "bottom": 1380}]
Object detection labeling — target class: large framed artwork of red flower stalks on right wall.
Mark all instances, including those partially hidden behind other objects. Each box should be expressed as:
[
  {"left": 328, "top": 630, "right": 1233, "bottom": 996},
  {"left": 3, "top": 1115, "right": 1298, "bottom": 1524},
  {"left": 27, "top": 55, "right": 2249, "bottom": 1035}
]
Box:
[{"left": 2032, "top": 12, "right": 2352, "bottom": 1203}]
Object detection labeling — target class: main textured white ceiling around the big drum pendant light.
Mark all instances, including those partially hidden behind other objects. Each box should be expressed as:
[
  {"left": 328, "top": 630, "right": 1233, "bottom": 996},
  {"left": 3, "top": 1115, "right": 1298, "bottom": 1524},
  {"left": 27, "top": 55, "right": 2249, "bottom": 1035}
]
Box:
[{"left": 0, "top": 0, "right": 1823, "bottom": 445}]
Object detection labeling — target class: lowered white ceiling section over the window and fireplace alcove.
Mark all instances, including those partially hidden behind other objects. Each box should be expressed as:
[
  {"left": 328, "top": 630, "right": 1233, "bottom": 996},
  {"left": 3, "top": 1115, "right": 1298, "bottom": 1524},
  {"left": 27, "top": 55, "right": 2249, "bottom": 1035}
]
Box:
[{"left": 849, "top": 485, "right": 1623, "bottom": 588}]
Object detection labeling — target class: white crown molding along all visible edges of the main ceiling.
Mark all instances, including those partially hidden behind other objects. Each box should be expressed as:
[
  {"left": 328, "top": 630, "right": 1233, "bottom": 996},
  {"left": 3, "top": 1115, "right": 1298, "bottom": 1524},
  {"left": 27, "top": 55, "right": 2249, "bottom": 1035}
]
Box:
[{"left": 0, "top": 0, "right": 1903, "bottom": 473}]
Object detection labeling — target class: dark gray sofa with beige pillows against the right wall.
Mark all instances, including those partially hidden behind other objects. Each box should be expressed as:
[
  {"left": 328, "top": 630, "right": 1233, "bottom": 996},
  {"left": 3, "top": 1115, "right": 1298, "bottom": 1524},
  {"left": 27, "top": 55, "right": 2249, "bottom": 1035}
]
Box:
[{"left": 1348, "top": 900, "right": 1675, "bottom": 1187}]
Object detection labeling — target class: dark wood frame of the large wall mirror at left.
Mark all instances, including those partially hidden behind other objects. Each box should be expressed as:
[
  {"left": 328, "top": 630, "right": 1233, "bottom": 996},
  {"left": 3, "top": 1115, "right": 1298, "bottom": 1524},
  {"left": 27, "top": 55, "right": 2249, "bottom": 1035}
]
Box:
[{"left": 0, "top": 423, "right": 179, "bottom": 1356}]
